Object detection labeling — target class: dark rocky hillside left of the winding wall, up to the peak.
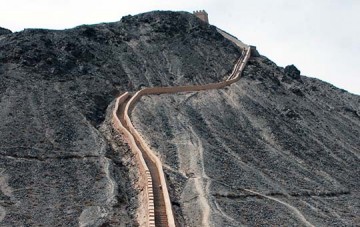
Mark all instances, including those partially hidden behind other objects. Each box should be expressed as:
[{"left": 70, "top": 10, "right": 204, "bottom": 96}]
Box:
[{"left": 0, "top": 12, "right": 240, "bottom": 226}]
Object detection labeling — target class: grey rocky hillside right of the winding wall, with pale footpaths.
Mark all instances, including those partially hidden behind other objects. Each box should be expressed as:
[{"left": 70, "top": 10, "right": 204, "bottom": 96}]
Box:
[{"left": 132, "top": 57, "right": 360, "bottom": 226}]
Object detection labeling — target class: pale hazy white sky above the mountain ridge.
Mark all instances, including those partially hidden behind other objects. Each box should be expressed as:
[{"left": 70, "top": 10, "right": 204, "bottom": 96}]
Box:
[{"left": 0, "top": 0, "right": 360, "bottom": 94}]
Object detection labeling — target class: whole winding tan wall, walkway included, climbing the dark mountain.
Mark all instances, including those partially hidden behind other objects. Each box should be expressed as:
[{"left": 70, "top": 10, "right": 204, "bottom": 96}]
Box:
[{"left": 113, "top": 15, "right": 252, "bottom": 227}]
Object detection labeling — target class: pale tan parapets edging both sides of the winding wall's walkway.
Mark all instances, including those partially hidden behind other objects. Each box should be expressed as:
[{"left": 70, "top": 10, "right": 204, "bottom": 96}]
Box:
[{"left": 113, "top": 30, "right": 250, "bottom": 227}]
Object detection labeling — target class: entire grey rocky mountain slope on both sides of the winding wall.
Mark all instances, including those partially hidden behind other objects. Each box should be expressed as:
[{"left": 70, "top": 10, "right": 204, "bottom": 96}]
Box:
[{"left": 0, "top": 12, "right": 360, "bottom": 226}]
